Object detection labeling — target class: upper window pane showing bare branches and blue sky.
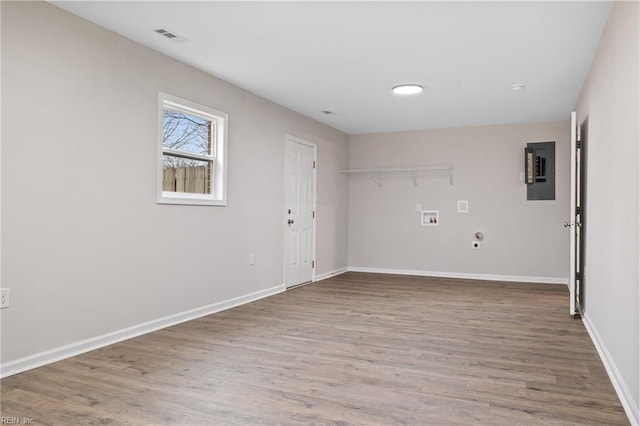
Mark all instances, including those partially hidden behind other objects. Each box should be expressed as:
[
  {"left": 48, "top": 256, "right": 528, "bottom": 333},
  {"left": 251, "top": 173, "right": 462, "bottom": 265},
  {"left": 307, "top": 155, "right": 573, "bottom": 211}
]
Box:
[{"left": 162, "top": 107, "right": 214, "bottom": 155}]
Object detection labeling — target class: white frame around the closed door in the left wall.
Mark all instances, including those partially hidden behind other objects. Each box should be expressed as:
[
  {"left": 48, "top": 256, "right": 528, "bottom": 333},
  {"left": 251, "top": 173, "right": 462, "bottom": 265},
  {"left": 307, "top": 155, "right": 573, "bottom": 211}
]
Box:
[{"left": 282, "top": 134, "right": 318, "bottom": 290}]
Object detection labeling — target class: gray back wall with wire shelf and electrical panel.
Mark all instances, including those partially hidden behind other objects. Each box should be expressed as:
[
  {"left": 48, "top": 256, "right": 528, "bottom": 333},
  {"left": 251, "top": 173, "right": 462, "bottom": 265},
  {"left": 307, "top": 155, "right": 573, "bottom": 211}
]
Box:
[{"left": 349, "top": 121, "right": 570, "bottom": 280}]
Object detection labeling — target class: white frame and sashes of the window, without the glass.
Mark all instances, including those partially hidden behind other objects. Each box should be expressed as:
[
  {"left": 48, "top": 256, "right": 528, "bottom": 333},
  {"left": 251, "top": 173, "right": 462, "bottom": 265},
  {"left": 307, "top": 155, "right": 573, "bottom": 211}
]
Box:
[{"left": 156, "top": 92, "right": 229, "bottom": 206}]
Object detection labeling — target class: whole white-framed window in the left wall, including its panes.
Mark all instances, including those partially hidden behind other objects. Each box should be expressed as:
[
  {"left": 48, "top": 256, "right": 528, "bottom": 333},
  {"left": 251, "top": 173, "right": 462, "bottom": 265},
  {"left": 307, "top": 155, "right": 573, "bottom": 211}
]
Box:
[{"left": 158, "top": 93, "right": 228, "bottom": 206}]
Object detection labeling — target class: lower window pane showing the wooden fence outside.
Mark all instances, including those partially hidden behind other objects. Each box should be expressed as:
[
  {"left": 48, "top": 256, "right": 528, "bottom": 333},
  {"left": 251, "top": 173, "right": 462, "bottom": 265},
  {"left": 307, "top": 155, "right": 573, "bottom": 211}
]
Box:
[{"left": 162, "top": 155, "right": 213, "bottom": 194}]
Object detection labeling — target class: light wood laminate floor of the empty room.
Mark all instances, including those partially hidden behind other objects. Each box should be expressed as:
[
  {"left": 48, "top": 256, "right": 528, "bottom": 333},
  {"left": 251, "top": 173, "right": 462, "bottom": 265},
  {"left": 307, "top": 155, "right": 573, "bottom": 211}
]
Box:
[{"left": 1, "top": 273, "right": 628, "bottom": 425}]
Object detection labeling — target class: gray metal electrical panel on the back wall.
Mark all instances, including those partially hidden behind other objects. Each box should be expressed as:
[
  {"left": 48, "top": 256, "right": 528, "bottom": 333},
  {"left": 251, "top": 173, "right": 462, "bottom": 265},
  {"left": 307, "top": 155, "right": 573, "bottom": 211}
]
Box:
[{"left": 524, "top": 142, "right": 556, "bottom": 200}]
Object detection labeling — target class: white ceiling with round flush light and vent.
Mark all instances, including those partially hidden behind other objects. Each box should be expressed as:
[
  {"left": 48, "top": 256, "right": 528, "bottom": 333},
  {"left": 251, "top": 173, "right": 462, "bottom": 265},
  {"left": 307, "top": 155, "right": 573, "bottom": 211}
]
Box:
[{"left": 54, "top": 1, "right": 611, "bottom": 134}]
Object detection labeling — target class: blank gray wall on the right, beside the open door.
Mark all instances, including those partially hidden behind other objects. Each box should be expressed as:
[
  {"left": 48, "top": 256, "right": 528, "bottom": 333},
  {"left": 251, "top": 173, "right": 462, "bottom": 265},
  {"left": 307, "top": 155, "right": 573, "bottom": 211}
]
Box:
[{"left": 577, "top": 2, "right": 640, "bottom": 422}]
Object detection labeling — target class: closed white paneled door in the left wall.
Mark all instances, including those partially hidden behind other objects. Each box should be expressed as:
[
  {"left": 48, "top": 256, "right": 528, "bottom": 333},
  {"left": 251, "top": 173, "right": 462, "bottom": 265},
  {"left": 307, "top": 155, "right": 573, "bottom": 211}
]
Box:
[{"left": 284, "top": 136, "right": 316, "bottom": 287}]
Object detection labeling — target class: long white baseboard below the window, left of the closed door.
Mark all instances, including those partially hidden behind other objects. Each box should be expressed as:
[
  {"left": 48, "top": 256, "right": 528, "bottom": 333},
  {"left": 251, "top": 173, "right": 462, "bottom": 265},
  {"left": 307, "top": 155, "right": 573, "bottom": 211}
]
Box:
[{"left": 0, "top": 284, "right": 285, "bottom": 377}]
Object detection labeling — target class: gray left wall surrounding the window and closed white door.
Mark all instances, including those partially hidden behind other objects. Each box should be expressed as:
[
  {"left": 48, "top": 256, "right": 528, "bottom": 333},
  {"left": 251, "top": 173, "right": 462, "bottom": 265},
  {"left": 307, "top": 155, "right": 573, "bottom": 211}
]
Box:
[{"left": 1, "top": 2, "right": 348, "bottom": 363}]
